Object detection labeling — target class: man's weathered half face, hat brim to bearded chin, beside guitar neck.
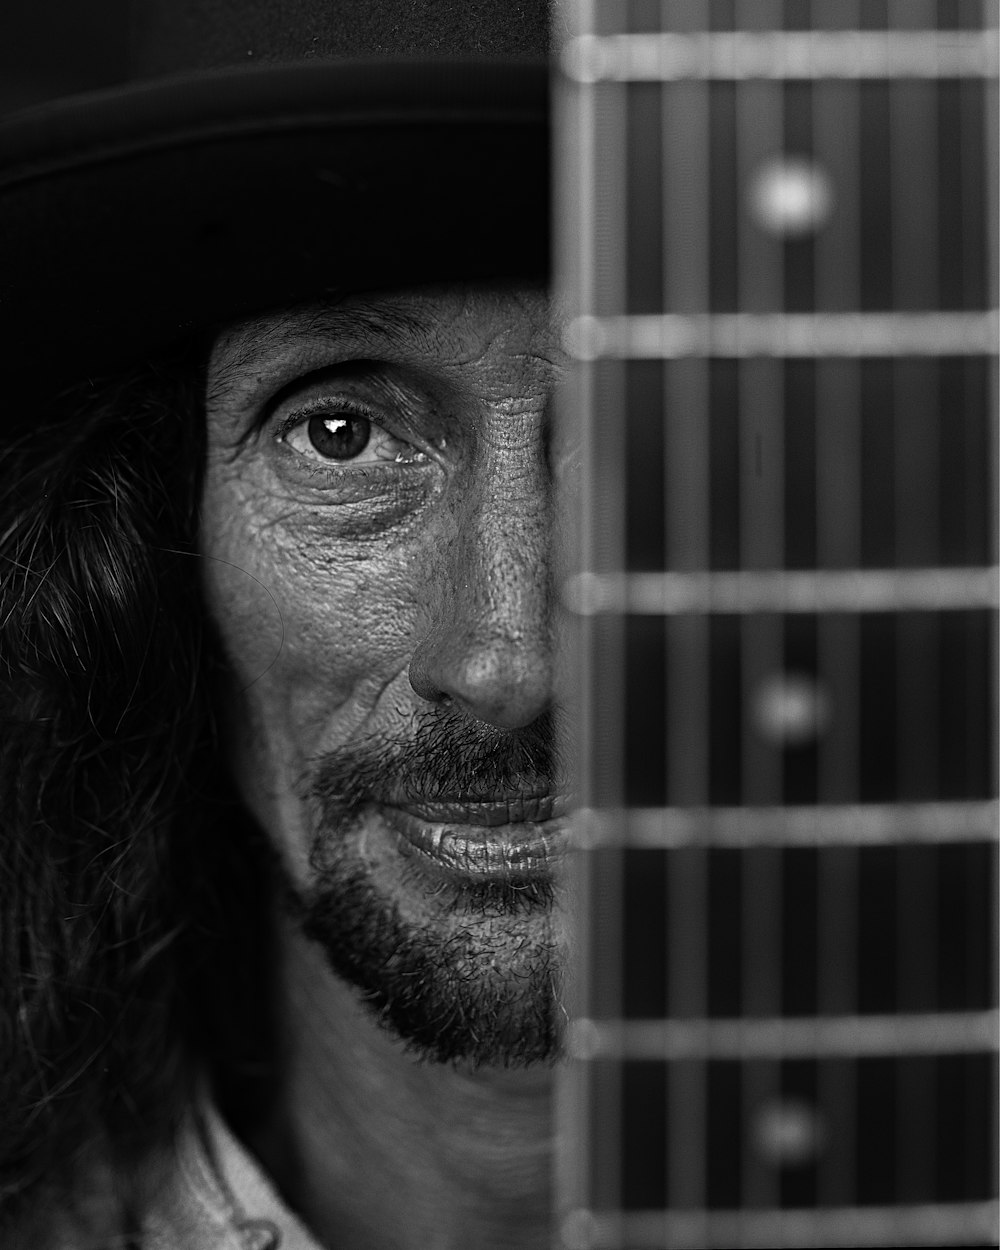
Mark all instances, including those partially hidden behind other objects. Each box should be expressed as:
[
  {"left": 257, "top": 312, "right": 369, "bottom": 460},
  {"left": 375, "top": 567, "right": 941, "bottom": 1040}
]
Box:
[{"left": 201, "top": 288, "right": 565, "bottom": 1064}]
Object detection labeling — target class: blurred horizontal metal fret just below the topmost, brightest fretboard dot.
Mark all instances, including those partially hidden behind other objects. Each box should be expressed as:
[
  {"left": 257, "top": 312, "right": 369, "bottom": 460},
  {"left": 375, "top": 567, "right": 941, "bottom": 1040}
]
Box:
[{"left": 564, "top": 310, "right": 1000, "bottom": 360}]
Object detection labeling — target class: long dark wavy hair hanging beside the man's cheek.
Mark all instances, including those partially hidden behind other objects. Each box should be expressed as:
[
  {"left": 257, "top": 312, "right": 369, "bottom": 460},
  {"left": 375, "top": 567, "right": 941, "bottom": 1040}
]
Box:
[{"left": 0, "top": 350, "right": 270, "bottom": 1246}]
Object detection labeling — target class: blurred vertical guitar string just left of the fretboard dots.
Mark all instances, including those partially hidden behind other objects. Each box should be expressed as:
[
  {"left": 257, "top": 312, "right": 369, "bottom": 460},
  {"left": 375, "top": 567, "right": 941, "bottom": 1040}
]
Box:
[{"left": 730, "top": 0, "right": 785, "bottom": 1209}]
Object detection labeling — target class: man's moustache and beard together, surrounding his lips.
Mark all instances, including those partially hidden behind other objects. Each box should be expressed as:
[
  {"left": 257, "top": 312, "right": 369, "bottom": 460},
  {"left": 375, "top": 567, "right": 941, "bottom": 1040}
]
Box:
[{"left": 295, "top": 709, "right": 564, "bottom": 1068}]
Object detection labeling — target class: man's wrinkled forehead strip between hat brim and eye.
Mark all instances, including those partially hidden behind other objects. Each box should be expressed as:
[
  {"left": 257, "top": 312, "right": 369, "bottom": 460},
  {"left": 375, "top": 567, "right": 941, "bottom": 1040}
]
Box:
[{"left": 209, "top": 285, "right": 561, "bottom": 399}]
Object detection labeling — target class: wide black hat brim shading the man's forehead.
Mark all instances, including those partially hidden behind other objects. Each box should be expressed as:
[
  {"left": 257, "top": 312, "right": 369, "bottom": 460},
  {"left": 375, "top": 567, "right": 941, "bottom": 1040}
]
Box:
[{"left": 0, "top": 60, "right": 550, "bottom": 384}]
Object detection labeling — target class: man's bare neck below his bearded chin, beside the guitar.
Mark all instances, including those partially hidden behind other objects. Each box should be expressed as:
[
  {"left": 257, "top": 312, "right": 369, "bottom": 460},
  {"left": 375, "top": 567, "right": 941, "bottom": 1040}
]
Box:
[{"left": 243, "top": 910, "right": 553, "bottom": 1250}]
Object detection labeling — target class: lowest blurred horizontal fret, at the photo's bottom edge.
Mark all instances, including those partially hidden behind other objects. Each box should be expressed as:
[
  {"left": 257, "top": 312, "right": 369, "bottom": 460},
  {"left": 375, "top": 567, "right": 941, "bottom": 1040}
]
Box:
[{"left": 561, "top": 1200, "right": 1000, "bottom": 1250}]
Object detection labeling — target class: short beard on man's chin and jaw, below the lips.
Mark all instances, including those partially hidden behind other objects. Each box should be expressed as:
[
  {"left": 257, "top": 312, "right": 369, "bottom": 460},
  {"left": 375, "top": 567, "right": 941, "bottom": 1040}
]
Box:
[{"left": 295, "top": 828, "right": 564, "bottom": 1068}]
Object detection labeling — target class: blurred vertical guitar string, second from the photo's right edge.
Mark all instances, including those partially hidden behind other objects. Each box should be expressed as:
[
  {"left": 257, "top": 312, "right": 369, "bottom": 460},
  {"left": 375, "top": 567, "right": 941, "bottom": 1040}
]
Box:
[{"left": 889, "top": 0, "right": 940, "bottom": 1201}]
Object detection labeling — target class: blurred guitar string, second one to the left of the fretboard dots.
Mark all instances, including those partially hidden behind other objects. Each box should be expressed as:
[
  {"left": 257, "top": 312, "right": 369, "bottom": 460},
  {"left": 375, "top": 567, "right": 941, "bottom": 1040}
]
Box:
[{"left": 660, "top": 0, "right": 711, "bottom": 1211}]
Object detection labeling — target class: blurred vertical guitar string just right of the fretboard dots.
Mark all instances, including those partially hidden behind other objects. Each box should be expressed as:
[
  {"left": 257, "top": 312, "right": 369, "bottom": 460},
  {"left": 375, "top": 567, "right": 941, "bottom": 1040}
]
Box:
[{"left": 813, "top": 0, "right": 861, "bottom": 1206}]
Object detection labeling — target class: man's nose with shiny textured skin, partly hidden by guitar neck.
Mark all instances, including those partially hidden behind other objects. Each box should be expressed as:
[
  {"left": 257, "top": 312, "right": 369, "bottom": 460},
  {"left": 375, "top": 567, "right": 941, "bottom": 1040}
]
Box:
[{"left": 410, "top": 452, "right": 553, "bottom": 729}]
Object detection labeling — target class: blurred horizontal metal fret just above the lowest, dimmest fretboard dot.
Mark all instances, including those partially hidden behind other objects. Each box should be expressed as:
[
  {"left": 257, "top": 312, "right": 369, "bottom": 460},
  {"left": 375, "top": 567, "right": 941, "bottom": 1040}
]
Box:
[{"left": 566, "top": 1009, "right": 1000, "bottom": 1064}]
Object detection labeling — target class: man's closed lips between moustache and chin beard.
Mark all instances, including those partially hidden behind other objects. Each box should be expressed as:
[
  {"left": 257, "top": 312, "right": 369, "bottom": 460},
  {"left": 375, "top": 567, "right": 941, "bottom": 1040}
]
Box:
[{"left": 379, "top": 795, "right": 570, "bottom": 879}]
